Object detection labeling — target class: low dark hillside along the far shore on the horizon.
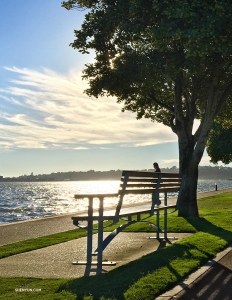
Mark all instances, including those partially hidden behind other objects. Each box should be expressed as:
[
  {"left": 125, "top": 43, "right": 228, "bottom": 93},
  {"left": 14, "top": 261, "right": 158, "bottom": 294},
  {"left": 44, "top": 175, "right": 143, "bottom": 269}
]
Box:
[{"left": 0, "top": 166, "right": 232, "bottom": 182}]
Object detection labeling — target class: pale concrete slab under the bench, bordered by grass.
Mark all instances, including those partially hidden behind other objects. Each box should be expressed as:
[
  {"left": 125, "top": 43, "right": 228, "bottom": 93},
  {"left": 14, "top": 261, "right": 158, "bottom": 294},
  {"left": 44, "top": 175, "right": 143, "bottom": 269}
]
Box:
[{"left": 0, "top": 232, "right": 190, "bottom": 278}]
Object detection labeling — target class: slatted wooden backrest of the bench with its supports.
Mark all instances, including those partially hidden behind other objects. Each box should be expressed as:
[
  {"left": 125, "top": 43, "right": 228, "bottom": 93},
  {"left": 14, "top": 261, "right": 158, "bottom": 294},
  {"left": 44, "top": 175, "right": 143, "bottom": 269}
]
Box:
[{"left": 116, "top": 171, "right": 181, "bottom": 216}]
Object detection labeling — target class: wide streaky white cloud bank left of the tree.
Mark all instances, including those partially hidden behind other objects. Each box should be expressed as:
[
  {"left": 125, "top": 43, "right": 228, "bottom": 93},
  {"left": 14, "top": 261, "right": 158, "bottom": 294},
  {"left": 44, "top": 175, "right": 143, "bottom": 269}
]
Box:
[{"left": 0, "top": 68, "right": 176, "bottom": 149}]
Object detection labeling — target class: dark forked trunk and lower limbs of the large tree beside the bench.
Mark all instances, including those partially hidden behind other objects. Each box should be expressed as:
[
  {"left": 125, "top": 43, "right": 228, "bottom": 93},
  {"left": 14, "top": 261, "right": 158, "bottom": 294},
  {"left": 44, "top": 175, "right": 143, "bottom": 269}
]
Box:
[{"left": 170, "top": 76, "right": 218, "bottom": 217}]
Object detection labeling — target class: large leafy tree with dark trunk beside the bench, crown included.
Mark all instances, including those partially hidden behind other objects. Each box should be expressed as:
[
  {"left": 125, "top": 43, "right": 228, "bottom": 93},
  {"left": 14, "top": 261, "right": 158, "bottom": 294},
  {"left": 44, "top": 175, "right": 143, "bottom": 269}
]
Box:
[{"left": 62, "top": 0, "right": 232, "bottom": 216}]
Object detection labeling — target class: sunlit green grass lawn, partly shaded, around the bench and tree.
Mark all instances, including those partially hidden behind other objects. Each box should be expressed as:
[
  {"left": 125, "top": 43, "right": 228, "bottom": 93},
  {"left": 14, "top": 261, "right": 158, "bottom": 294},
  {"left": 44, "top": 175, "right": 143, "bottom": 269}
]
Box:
[{"left": 0, "top": 193, "right": 232, "bottom": 300}]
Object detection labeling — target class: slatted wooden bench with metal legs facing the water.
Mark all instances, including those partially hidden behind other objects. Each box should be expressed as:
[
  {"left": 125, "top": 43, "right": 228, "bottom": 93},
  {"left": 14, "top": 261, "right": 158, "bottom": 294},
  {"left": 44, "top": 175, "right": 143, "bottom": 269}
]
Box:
[{"left": 72, "top": 171, "right": 181, "bottom": 273}]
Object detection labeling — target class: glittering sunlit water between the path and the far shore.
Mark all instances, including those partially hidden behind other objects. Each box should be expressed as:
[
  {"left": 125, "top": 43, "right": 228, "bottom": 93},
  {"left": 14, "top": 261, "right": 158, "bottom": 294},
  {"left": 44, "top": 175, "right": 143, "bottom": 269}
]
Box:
[{"left": 0, "top": 180, "right": 232, "bottom": 224}]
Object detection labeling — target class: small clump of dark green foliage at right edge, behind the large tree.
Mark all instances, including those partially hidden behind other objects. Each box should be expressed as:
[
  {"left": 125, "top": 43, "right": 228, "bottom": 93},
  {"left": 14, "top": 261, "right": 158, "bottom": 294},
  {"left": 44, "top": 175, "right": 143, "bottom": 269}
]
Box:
[{"left": 206, "top": 122, "right": 232, "bottom": 164}]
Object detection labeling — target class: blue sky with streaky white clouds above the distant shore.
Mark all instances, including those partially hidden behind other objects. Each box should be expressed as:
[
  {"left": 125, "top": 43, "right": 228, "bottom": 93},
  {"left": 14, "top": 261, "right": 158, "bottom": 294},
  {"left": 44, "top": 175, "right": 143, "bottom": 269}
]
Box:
[{"left": 0, "top": 0, "right": 228, "bottom": 177}]
